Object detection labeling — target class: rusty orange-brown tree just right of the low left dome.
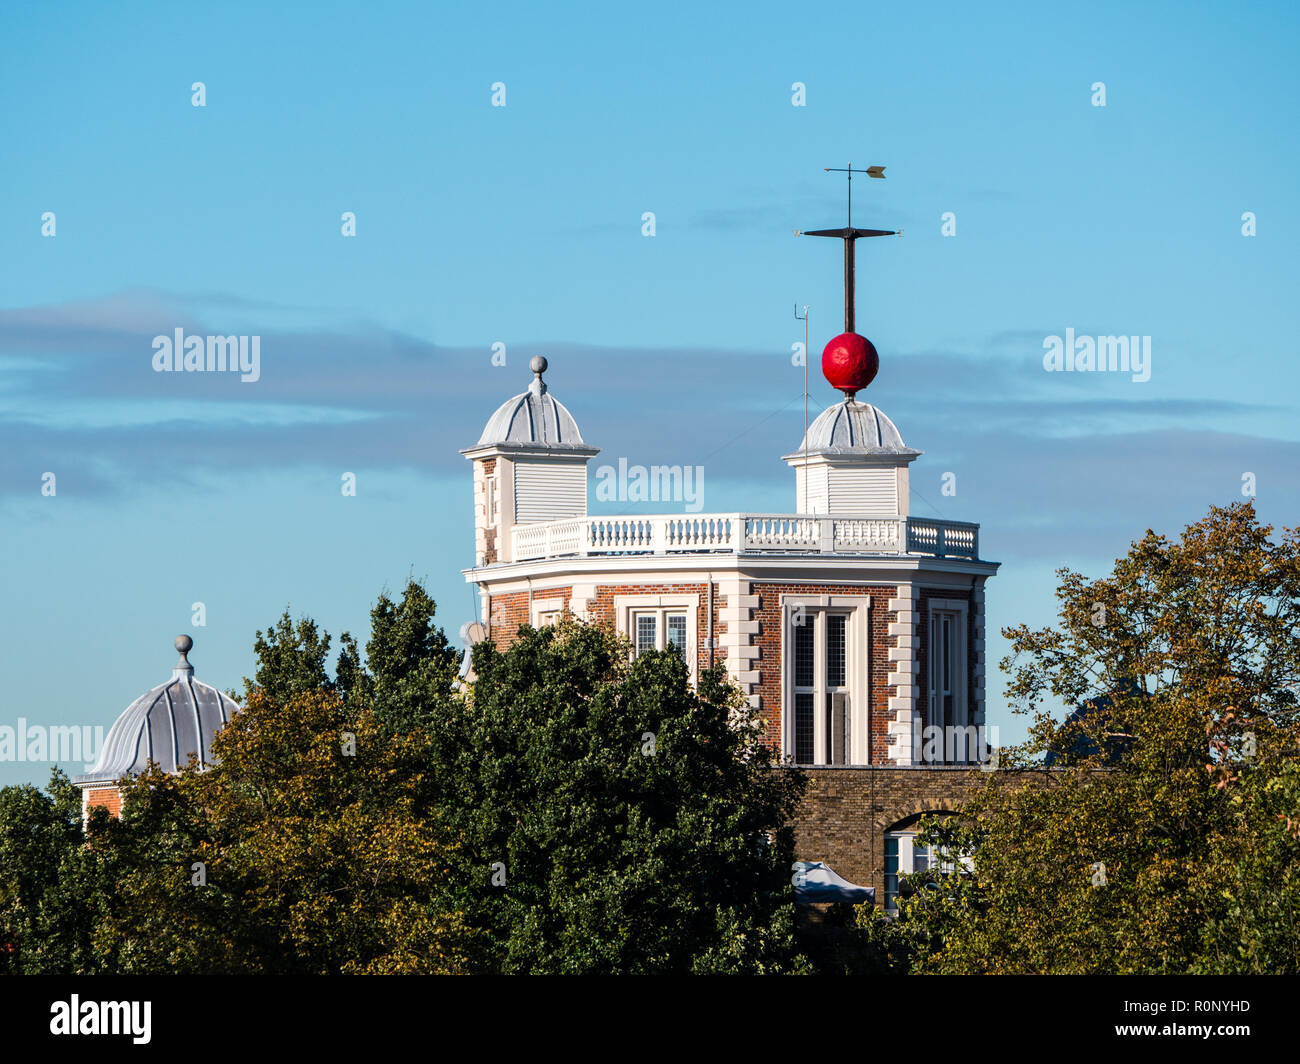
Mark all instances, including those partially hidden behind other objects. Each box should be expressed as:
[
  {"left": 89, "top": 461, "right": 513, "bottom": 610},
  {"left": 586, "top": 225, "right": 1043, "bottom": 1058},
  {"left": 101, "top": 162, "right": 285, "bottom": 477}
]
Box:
[{"left": 91, "top": 689, "right": 465, "bottom": 974}]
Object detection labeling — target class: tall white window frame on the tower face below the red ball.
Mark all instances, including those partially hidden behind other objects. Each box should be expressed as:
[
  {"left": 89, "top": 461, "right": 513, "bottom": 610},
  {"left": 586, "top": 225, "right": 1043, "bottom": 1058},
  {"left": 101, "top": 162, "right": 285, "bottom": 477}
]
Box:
[{"left": 781, "top": 594, "right": 871, "bottom": 765}]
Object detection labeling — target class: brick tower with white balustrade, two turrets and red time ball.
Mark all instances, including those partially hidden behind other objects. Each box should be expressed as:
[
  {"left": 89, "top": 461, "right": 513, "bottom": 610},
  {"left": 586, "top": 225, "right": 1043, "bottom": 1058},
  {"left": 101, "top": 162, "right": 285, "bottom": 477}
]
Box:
[{"left": 463, "top": 178, "right": 998, "bottom": 911}]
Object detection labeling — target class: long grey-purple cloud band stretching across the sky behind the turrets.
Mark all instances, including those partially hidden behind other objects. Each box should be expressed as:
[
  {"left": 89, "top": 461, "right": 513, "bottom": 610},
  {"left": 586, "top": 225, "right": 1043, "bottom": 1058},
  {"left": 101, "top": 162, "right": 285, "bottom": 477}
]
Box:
[{"left": 0, "top": 291, "right": 1300, "bottom": 557}]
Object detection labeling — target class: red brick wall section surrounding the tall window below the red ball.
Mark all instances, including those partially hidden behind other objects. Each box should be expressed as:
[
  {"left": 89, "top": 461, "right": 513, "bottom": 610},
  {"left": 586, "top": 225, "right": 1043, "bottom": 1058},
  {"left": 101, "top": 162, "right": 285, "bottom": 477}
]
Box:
[{"left": 750, "top": 583, "right": 897, "bottom": 765}]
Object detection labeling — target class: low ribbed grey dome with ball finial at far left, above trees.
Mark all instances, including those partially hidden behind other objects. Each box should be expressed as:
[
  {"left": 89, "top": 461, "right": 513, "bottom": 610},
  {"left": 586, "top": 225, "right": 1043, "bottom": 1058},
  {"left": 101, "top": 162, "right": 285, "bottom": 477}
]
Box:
[{"left": 77, "top": 636, "right": 239, "bottom": 783}]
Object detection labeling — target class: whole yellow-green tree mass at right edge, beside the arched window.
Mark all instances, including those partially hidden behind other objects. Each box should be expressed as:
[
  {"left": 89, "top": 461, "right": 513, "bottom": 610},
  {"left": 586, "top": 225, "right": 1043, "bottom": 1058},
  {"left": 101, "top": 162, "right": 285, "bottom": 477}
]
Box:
[{"left": 863, "top": 503, "right": 1300, "bottom": 973}]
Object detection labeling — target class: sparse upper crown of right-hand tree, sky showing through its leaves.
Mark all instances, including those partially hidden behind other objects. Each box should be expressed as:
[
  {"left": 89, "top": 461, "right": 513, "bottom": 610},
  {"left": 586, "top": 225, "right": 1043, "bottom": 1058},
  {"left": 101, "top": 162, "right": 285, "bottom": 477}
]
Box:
[{"left": 1004, "top": 502, "right": 1300, "bottom": 733}]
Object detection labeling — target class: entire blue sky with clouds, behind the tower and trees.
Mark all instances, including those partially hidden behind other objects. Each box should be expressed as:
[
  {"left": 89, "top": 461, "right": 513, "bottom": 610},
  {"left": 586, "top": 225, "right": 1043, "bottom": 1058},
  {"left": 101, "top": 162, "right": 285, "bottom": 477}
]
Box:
[{"left": 0, "top": 3, "right": 1300, "bottom": 783}]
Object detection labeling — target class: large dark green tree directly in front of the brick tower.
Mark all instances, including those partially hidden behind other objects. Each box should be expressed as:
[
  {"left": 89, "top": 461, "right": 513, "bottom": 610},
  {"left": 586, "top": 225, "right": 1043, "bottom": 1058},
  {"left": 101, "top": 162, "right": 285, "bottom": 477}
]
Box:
[{"left": 429, "top": 619, "right": 802, "bottom": 973}]
